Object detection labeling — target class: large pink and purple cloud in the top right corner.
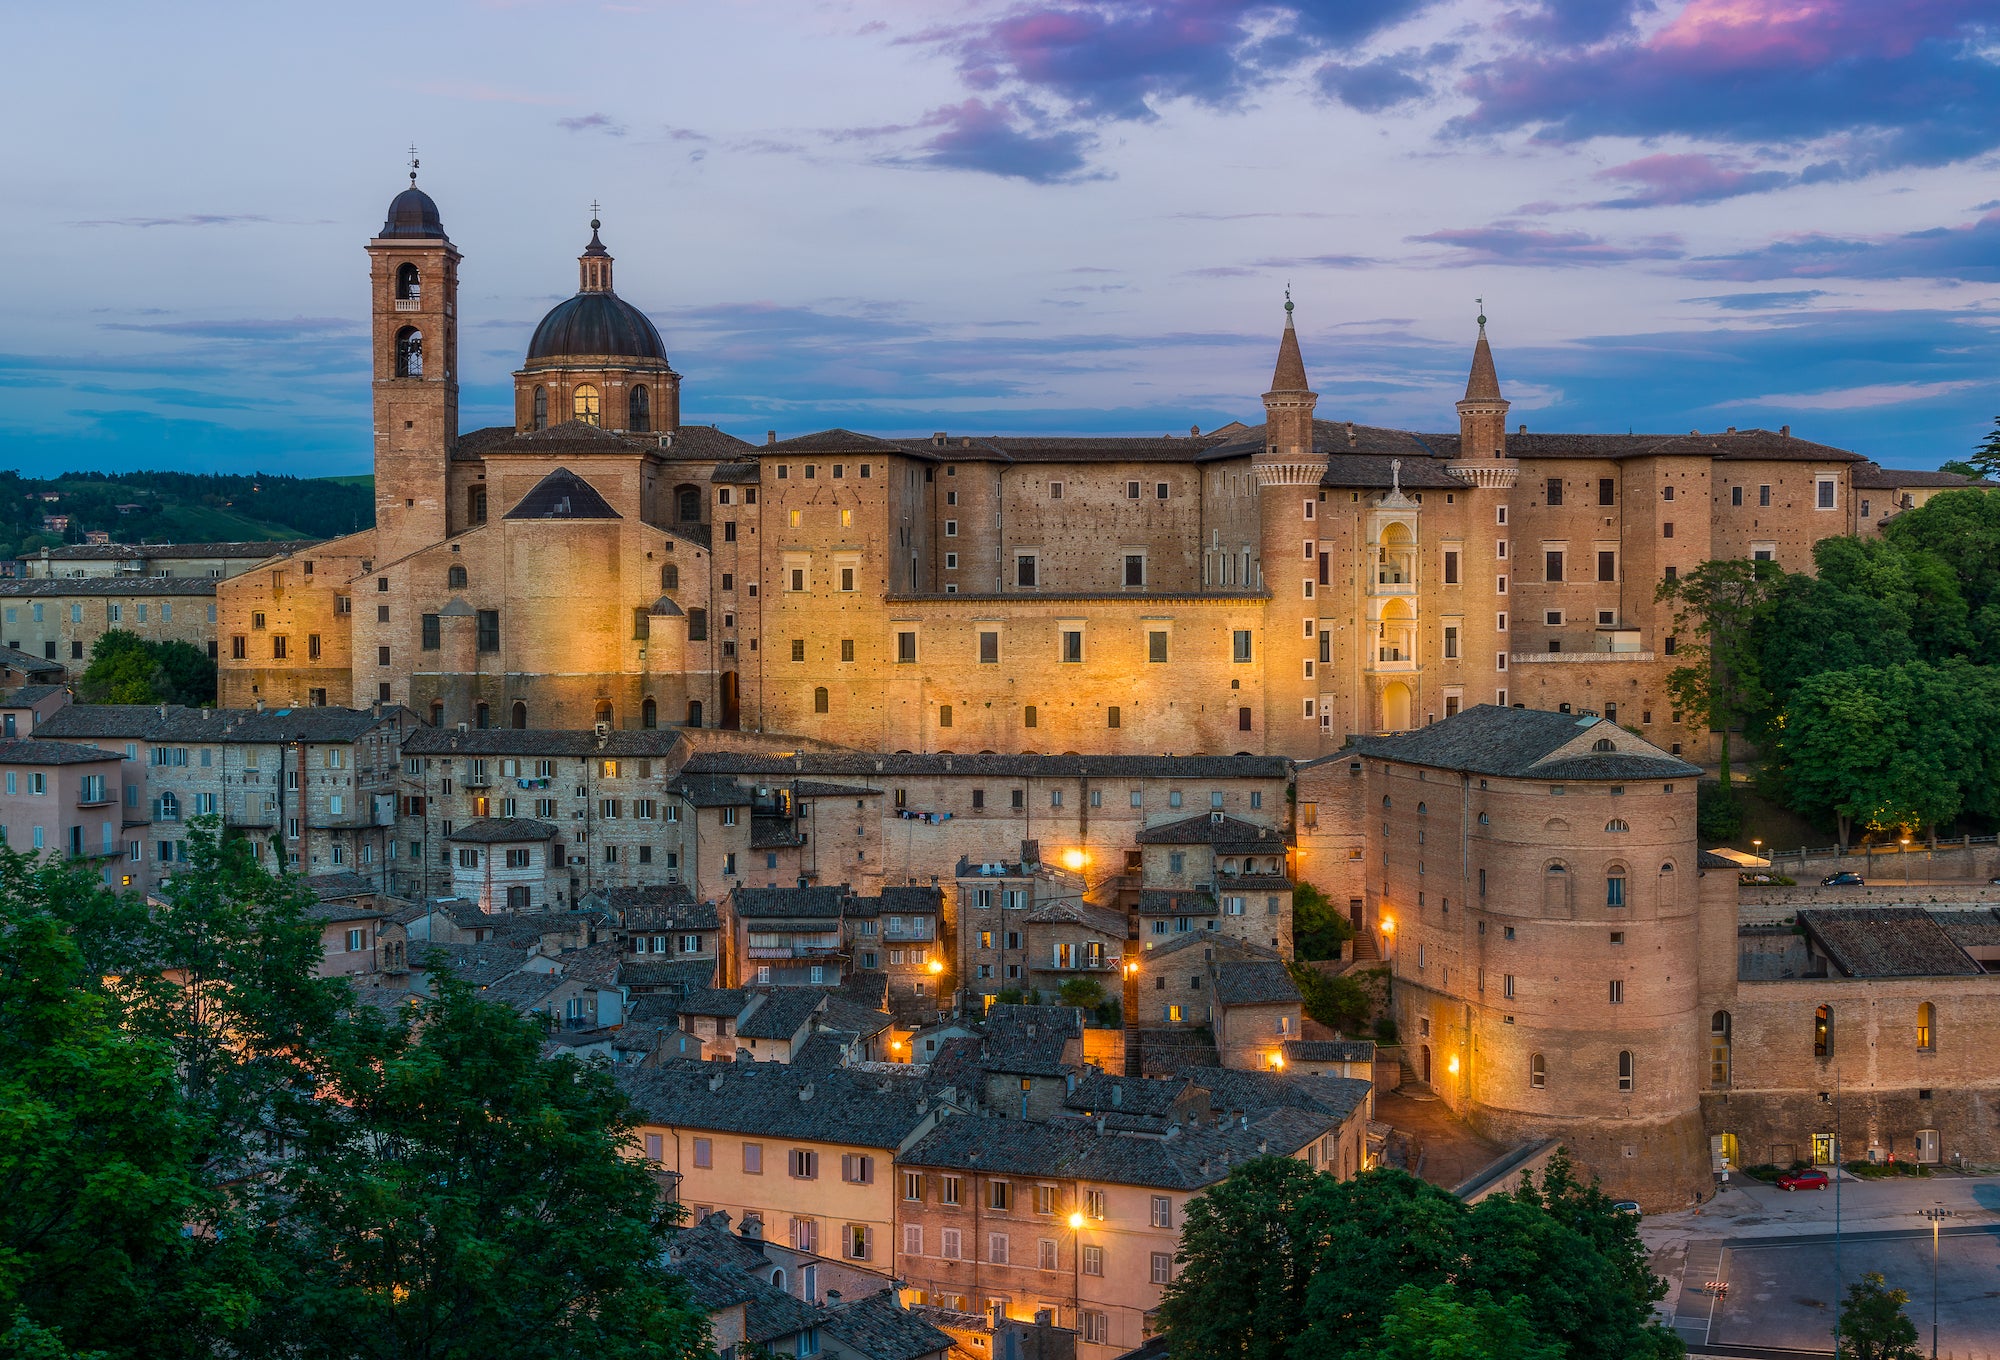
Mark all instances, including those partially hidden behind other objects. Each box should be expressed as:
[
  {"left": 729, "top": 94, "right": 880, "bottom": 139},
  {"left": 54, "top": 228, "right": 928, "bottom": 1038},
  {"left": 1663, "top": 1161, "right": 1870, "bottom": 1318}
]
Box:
[{"left": 1450, "top": 0, "right": 2000, "bottom": 180}]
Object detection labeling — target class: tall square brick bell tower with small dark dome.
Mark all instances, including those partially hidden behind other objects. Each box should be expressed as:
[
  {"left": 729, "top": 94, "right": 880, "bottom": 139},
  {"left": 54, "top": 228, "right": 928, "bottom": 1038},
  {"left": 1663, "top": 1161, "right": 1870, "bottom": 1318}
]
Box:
[{"left": 368, "top": 154, "right": 460, "bottom": 562}]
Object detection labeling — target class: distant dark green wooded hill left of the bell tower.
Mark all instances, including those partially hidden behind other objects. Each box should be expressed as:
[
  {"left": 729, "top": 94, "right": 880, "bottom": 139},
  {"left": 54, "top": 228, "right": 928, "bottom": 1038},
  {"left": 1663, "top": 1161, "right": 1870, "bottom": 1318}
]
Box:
[{"left": 0, "top": 472, "right": 374, "bottom": 558}]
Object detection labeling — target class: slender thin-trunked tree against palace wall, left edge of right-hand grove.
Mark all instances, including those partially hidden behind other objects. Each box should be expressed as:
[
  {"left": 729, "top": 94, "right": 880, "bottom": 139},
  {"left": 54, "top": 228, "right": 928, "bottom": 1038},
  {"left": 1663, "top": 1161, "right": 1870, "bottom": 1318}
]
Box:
[{"left": 1656, "top": 558, "right": 1784, "bottom": 790}]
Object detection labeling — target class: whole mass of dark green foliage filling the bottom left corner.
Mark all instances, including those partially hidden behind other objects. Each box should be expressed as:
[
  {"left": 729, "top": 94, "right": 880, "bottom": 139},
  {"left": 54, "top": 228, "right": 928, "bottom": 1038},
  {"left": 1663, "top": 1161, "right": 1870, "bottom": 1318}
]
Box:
[{"left": 0, "top": 820, "right": 708, "bottom": 1360}]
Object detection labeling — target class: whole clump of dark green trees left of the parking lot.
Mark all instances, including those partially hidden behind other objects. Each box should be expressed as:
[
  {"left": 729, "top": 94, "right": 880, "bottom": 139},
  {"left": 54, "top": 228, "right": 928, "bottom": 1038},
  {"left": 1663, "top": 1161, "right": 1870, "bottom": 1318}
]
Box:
[{"left": 1160, "top": 1152, "right": 1682, "bottom": 1360}]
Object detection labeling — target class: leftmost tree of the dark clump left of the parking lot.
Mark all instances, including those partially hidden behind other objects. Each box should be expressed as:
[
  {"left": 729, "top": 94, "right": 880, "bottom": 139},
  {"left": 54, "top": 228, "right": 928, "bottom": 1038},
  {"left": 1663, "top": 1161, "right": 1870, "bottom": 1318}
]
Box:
[{"left": 1160, "top": 1156, "right": 1326, "bottom": 1360}]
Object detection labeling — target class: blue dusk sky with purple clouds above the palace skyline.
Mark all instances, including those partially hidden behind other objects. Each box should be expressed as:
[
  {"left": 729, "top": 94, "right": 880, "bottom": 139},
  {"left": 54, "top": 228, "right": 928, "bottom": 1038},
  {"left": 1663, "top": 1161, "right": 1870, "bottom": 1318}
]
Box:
[{"left": 0, "top": 0, "right": 2000, "bottom": 476}]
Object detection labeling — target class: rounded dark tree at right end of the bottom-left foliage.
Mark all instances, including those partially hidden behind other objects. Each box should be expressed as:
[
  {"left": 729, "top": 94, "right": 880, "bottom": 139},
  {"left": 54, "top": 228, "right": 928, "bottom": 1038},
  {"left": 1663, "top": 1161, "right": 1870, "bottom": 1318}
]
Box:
[{"left": 249, "top": 980, "right": 708, "bottom": 1360}]
